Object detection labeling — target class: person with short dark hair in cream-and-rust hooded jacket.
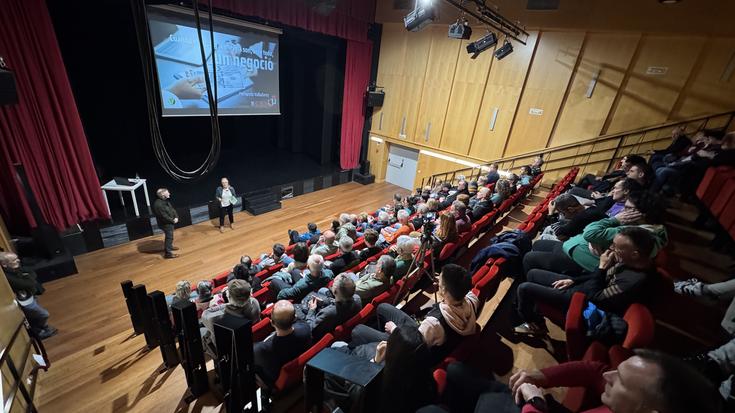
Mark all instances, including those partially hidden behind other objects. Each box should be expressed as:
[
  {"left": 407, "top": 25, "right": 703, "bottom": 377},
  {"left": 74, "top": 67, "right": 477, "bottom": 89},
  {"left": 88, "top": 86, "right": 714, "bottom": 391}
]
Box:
[{"left": 351, "top": 264, "right": 478, "bottom": 362}]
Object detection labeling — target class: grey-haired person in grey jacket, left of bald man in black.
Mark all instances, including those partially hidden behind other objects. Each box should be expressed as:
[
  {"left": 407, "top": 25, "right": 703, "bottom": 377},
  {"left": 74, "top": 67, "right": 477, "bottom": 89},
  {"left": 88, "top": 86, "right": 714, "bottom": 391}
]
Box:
[{"left": 201, "top": 280, "right": 260, "bottom": 354}]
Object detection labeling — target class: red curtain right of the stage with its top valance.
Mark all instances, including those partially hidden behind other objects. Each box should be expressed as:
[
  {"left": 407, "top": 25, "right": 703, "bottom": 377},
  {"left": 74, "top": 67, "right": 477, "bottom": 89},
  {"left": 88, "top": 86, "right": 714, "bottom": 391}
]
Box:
[{"left": 212, "top": 0, "right": 375, "bottom": 169}]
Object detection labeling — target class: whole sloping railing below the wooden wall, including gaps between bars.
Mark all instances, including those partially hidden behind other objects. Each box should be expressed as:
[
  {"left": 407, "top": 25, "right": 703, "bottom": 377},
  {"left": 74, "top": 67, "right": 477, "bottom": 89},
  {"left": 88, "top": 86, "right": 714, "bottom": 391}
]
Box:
[{"left": 421, "top": 111, "right": 735, "bottom": 188}]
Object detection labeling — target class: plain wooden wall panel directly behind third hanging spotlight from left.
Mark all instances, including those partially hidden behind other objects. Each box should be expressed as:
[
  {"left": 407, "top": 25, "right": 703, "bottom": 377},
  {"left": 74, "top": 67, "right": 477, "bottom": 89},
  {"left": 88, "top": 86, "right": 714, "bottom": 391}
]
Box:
[{"left": 439, "top": 30, "right": 495, "bottom": 155}]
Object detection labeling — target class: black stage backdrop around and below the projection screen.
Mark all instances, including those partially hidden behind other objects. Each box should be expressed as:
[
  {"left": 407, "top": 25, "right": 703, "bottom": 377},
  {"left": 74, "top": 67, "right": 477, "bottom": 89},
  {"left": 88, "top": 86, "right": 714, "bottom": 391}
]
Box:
[{"left": 47, "top": 0, "right": 346, "bottom": 206}]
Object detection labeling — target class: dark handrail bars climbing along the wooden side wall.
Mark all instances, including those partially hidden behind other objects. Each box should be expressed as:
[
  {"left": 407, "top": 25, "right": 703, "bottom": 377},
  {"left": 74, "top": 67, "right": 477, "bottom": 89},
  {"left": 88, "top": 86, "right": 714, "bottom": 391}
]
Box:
[{"left": 421, "top": 110, "right": 735, "bottom": 187}]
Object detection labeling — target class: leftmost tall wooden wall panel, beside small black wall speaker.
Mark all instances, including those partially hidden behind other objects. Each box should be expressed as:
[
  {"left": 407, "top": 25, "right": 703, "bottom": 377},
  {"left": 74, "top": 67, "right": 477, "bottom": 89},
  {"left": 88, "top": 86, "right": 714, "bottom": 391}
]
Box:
[{"left": 371, "top": 24, "right": 406, "bottom": 136}]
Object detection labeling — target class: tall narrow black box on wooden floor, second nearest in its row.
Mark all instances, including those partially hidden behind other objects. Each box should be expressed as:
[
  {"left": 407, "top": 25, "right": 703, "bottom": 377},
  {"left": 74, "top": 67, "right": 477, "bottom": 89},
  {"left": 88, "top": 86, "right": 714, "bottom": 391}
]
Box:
[{"left": 171, "top": 302, "right": 209, "bottom": 403}]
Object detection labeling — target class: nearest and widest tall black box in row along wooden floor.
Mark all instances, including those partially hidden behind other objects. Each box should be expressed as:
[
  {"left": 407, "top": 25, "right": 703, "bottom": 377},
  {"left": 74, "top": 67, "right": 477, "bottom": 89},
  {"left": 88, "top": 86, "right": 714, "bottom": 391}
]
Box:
[{"left": 214, "top": 313, "right": 257, "bottom": 412}]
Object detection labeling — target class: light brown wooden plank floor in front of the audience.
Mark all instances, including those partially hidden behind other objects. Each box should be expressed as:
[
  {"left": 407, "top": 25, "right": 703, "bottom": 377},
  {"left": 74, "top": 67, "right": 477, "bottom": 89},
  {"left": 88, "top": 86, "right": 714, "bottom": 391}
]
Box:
[{"left": 36, "top": 182, "right": 407, "bottom": 413}]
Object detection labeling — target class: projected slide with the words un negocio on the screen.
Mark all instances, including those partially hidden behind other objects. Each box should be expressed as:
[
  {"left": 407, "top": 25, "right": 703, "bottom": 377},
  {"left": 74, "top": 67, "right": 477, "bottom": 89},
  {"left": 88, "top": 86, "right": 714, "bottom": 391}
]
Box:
[{"left": 148, "top": 6, "right": 280, "bottom": 116}]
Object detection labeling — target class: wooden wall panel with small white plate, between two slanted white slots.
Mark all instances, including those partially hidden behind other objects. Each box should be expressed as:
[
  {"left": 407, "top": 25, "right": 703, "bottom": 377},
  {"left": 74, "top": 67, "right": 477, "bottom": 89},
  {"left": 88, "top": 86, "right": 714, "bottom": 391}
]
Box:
[{"left": 503, "top": 32, "right": 585, "bottom": 156}]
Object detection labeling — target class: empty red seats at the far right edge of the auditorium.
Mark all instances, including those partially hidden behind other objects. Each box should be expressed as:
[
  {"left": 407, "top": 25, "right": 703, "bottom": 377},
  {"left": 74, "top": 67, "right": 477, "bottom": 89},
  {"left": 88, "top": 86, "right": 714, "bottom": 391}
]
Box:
[{"left": 697, "top": 166, "right": 735, "bottom": 238}]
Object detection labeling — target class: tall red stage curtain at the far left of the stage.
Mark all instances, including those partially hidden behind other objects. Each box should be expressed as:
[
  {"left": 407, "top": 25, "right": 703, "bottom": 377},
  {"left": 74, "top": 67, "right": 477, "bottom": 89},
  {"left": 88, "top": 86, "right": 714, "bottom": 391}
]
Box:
[{"left": 0, "top": 0, "right": 108, "bottom": 231}]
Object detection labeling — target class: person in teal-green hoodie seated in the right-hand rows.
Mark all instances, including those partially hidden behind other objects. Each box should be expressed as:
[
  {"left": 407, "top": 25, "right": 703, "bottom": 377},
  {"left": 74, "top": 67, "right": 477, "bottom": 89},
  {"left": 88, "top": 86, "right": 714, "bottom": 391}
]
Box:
[{"left": 523, "top": 192, "right": 668, "bottom": 277}]
